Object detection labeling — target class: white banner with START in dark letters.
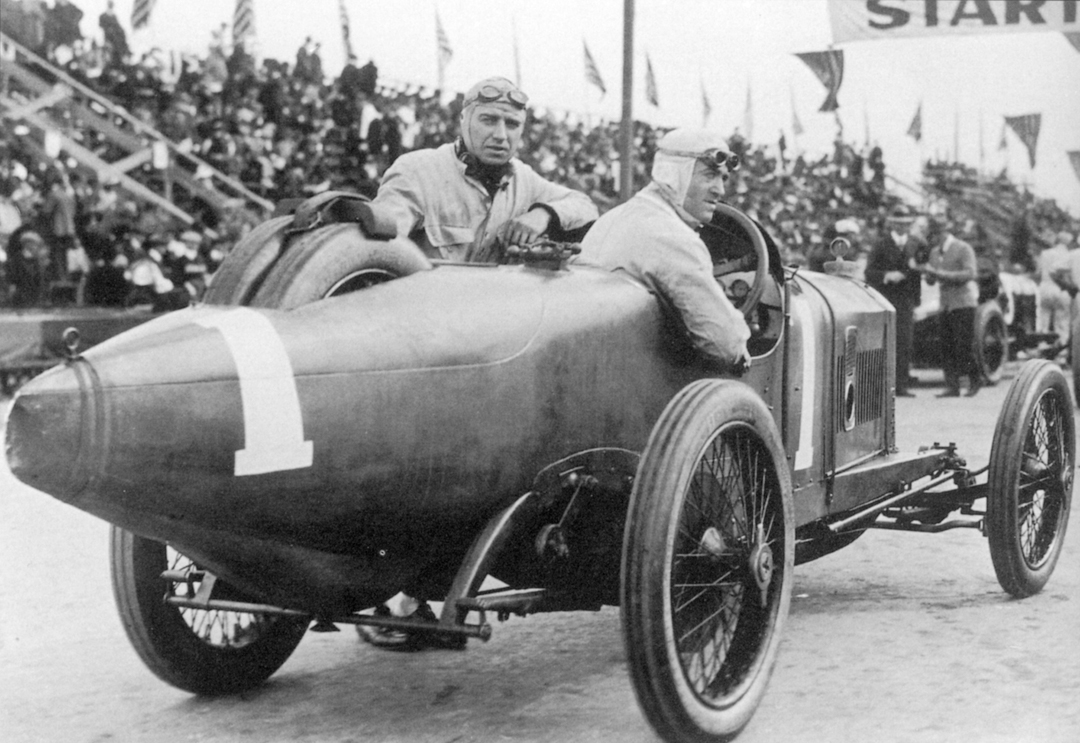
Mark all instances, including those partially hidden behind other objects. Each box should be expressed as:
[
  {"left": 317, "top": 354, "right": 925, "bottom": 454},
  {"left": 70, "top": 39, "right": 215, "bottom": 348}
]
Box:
[{"left": 828, "top": 0, "right": 1080, "bottom": 43}]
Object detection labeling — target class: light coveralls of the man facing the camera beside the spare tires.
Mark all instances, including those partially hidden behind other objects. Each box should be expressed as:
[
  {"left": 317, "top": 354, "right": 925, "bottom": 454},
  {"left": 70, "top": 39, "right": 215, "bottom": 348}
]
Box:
[{"left": 374, "top": 143, "right": 597, "bottom": 260}]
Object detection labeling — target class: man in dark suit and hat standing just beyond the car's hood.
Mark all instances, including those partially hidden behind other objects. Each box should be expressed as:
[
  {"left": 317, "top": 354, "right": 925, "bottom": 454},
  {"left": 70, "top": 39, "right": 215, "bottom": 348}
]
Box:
[{"left": 866, "top": 205, "right": 926, "bottom": 397}]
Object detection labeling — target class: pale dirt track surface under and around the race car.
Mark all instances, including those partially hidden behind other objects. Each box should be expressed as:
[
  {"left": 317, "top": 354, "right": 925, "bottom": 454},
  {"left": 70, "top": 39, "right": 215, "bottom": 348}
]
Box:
[{"left": 0, "top": 365, "right": 1080, "bottom": 743}]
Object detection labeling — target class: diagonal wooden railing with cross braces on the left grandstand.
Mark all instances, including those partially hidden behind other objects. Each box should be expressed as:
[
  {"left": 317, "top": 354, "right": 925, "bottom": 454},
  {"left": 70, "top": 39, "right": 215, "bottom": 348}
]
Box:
[{"left": 0, "top": 33, "right": 274, "bottom": 225}]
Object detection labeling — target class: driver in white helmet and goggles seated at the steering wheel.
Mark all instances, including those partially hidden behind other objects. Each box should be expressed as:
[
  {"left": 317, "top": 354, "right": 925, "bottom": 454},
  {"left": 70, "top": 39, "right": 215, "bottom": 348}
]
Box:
[{"left": 578, "top": 130, "right": 750, "bottom": 370}]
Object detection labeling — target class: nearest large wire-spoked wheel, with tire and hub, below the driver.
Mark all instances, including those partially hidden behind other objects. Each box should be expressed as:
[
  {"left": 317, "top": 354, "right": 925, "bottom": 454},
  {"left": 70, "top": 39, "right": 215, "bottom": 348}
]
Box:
[{"left": 621, "top": 380, "right": 795, "bottom": 741}]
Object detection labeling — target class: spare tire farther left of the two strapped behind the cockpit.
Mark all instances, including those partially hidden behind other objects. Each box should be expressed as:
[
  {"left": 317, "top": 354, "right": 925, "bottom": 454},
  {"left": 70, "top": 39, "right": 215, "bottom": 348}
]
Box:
[{"left": 203, "top": 215, "right": 293, "bottom": 305}]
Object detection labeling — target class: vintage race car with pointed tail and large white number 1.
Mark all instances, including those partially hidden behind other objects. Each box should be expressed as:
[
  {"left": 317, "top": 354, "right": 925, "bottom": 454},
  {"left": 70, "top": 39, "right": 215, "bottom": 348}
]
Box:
[{"left": 6, "top": 194, "right": 1075, "bottom": 741}]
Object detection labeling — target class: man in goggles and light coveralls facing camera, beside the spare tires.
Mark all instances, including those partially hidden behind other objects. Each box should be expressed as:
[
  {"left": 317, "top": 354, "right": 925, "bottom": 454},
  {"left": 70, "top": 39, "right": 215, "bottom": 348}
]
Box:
[{"left": 374, "top": 78, "right": 597, "bottom": 262}]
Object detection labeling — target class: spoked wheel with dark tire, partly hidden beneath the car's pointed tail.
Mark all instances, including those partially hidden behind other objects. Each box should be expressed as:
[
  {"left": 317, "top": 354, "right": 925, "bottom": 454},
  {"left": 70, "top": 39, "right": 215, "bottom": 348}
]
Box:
[{"left": 109, "top": 527, "right": 308, "bottom": 694}]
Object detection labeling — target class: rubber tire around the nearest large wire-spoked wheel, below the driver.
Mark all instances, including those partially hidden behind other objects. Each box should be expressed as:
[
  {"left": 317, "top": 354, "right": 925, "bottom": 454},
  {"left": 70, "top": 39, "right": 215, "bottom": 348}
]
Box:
[{"left": 621, "top": 379, "right": 795, "bottom": 741}]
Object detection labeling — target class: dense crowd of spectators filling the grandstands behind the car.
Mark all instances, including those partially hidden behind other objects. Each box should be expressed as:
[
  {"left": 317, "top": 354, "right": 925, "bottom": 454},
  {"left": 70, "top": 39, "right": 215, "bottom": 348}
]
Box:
[{"left": 0, "top": 0, "right": 1069, "bottom": 306}]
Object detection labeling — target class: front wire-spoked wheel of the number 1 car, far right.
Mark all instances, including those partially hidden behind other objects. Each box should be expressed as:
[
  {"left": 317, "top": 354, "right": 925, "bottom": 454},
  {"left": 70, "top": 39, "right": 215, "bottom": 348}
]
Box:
[{"left": 986, "top": 361, "right": 1076, "bottom": 598}]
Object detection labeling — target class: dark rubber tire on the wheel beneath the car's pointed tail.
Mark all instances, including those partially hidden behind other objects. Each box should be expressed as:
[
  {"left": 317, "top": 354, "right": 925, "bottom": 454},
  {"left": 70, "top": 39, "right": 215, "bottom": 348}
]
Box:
[{"left": 109, "top": 526, "right": 308, "bottom": 694}]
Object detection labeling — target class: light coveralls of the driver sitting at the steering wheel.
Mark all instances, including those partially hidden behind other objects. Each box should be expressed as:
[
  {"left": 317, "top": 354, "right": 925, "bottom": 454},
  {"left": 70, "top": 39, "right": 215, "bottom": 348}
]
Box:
[{"left": 578, "top": 183, "right": 750, "bottom": 366}]
